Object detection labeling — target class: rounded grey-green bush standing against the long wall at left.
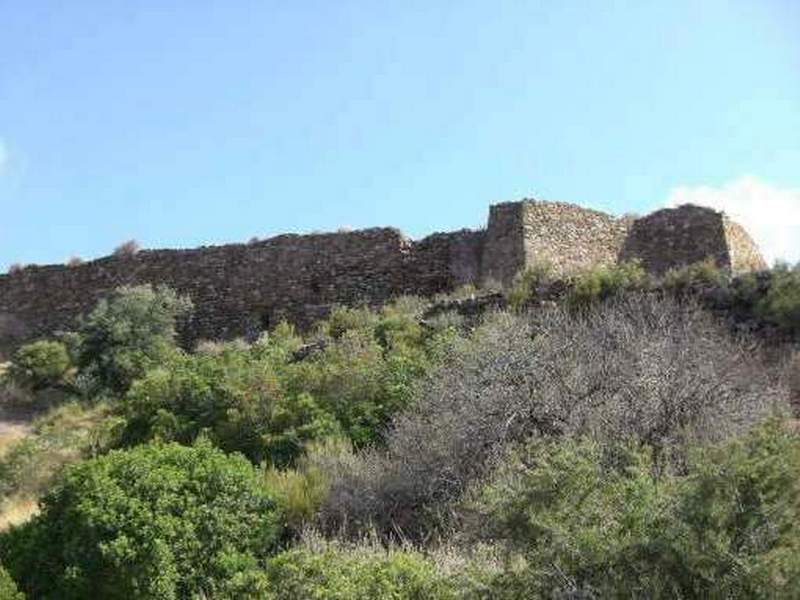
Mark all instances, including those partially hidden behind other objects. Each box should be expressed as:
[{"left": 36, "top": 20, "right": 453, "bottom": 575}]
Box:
[{"left": 78, "top": 285, "right": 191, "bottom": 393}]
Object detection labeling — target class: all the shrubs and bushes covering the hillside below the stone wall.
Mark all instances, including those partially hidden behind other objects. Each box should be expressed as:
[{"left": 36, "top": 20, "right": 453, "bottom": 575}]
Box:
[{"left": 0, "top": 262, "right": 800, "bottom": 599}]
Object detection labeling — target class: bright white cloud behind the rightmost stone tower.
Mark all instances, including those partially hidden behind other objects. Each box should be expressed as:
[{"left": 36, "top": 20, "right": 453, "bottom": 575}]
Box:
[{"left": 666, "top": 176, "right": 800, "bottom": 264}]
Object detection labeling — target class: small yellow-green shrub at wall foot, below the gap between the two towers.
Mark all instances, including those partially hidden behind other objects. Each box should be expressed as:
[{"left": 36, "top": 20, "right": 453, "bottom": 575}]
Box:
[{"left": 567, "top": 260, "right": 649, "bottom": 309}]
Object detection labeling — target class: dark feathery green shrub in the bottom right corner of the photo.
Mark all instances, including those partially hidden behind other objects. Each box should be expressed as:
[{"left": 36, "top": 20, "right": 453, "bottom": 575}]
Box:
[{"left": 659, "top": 422, "right": 800, "bottom": 598}]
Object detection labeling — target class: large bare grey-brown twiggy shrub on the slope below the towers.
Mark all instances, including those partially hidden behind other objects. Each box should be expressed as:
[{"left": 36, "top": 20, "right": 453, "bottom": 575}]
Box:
[{"left": 321, "top": 296, "right": 787, "bottom": 540}]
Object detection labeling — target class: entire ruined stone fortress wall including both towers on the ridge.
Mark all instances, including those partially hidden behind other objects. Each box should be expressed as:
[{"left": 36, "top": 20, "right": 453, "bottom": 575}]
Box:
[{"left": 0, "top": 201, "right": 764, "bottom": 354}]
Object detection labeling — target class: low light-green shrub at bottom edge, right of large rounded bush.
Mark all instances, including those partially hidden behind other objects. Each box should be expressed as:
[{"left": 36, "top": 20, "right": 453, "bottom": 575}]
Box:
[{"left": 267, "top": 544, "right": 456, "bottom": 600}]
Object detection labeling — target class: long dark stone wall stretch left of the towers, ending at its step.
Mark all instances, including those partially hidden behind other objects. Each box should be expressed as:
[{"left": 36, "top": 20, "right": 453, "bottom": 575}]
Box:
[{"left": 0, "top": 229, "right": 411, "bottom": 354}]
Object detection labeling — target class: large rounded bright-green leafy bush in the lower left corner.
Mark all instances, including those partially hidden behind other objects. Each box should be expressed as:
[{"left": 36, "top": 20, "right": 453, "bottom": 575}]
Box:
[{"left": 0, "top": 443, "right": 282, "bottom": 600}]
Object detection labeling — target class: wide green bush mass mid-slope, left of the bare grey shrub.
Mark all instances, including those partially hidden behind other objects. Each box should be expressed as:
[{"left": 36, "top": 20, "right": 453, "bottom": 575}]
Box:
[{"left": 123, "top": 300, "right": 455, "bottom": 467}]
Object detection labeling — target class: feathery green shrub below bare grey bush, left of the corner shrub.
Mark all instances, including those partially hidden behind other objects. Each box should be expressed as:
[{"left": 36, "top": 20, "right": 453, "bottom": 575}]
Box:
[{"left": 481, "top": 439, "right": 669, "bottom": 598}]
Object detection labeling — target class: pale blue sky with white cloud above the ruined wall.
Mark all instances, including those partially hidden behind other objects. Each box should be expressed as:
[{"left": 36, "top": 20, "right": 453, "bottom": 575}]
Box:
[{"left": 0, "top": 0, "right": 800, "bottom": 270}]
